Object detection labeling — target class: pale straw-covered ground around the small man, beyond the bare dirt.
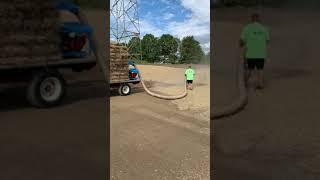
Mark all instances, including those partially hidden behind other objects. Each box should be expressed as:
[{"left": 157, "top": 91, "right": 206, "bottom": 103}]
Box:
[{"left": 139, "top": 65, "right": 210, "bottom": 120}]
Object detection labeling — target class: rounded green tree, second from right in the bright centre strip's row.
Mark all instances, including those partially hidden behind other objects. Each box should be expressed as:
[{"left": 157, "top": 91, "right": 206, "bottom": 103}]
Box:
[{"left": 158, "top": 34, "right": 178, "bottom": 62}]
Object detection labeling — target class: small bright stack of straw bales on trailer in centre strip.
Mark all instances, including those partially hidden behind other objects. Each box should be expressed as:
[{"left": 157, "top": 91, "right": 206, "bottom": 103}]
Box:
[{"left": 110, "top": 43, "right": 128, "bottom": 83}]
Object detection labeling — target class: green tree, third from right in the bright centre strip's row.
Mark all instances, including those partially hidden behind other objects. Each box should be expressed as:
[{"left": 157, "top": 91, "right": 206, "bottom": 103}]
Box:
[{"left": 141, "top": 34, "right": 159, "bottom": 63}]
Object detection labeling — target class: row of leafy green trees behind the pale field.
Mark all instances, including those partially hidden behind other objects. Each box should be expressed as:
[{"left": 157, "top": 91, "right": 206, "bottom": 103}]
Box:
[{"left": 128, "top": 34, "right": 210, "bottom": 64}]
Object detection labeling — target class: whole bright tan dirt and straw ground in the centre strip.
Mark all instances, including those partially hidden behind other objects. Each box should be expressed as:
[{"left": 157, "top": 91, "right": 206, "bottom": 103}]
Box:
[{"left": 110, "top": 65, "right": 209, "bottom": 180}]
